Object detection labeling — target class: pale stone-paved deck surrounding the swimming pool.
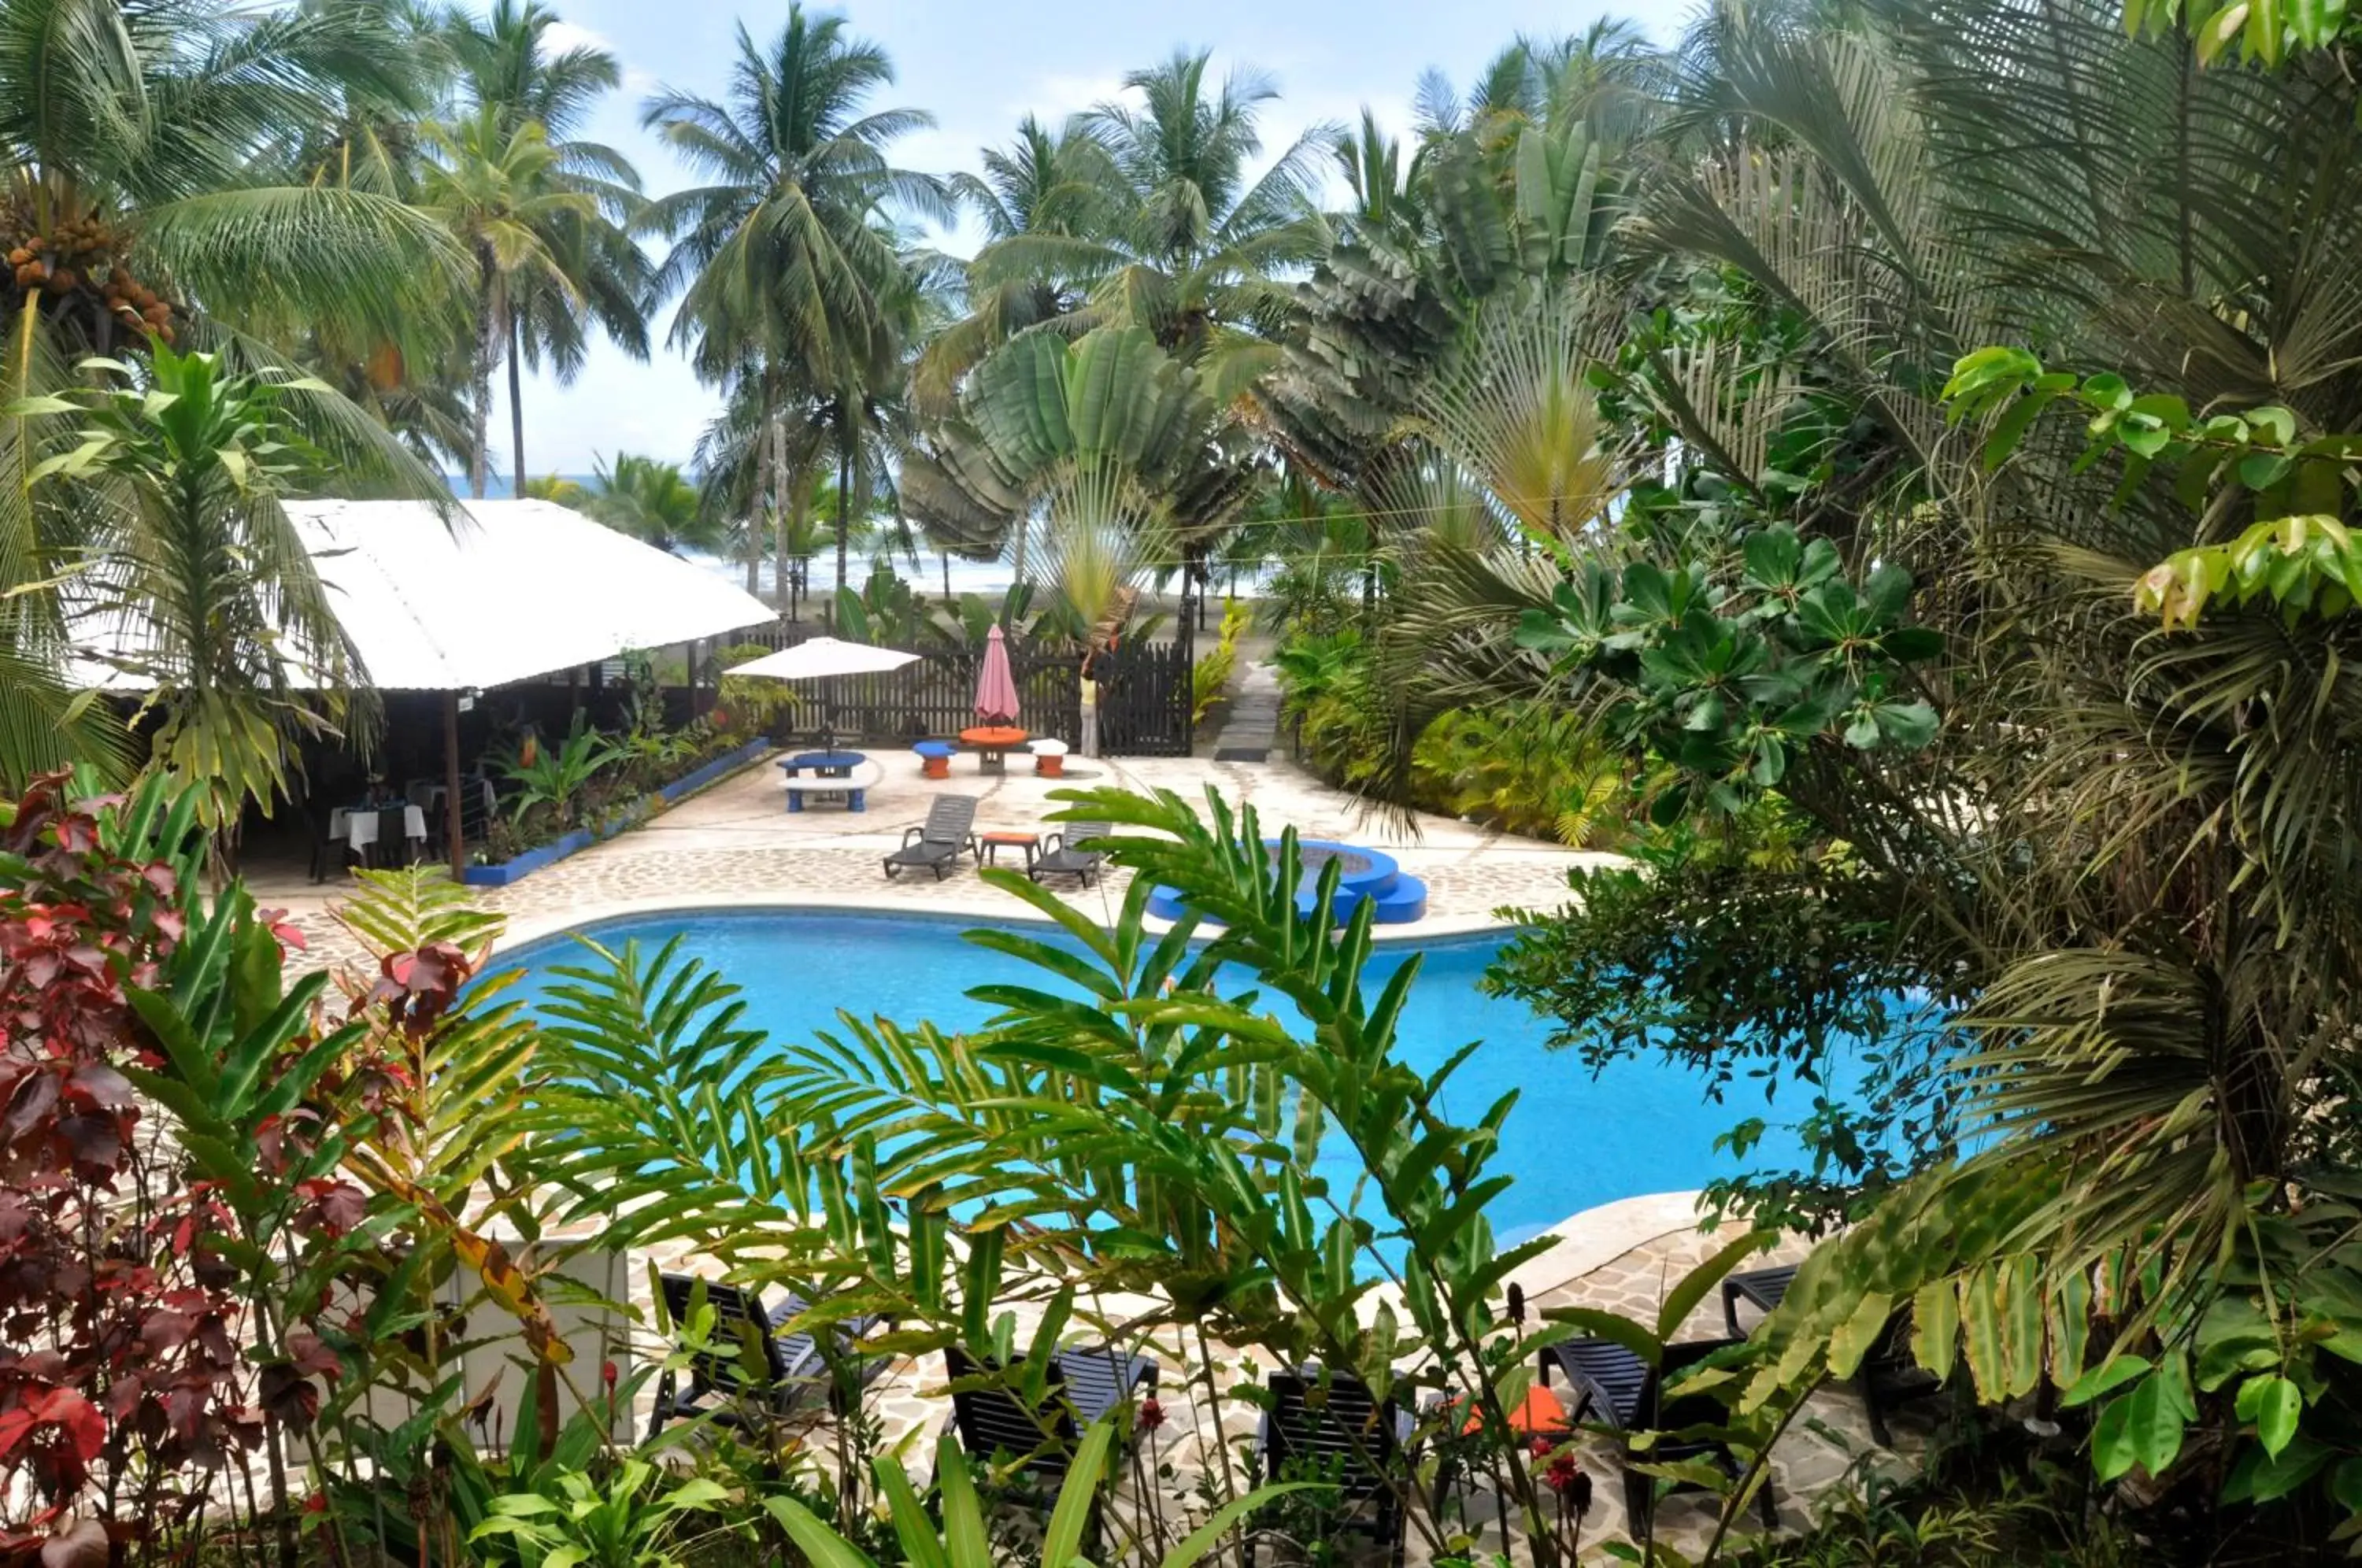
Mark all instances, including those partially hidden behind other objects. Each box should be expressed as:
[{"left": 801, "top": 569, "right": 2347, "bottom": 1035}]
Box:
[{"left": 250, "top": 751, "right": 1899, "bottom": 1563}]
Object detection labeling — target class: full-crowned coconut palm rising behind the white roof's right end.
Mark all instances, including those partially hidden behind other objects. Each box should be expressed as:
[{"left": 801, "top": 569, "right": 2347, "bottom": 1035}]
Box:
[{"left": 642, "top": 2, "right": 952, "bottom": 605}]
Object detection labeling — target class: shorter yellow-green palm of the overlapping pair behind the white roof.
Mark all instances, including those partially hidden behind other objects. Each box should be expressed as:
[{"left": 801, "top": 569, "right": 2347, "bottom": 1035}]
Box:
[{"left": 420, "top": 104, "right": 600, "bottom": 498}]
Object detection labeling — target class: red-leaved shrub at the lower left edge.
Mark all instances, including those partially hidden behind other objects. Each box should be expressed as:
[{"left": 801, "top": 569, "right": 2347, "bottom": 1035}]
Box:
[{"left": 0, "top": 775, "right": 361, "bottom": 1568}]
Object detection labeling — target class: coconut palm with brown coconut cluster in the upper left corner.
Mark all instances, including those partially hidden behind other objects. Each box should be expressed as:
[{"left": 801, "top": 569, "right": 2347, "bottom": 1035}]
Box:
[{"left": 0, "top": 0, "right": 461, "bottom": 786}]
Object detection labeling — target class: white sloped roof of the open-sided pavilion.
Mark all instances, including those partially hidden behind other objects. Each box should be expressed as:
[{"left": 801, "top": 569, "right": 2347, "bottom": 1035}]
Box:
[{"left": 71, "top": 501, "right": 777, "bottom": 692}]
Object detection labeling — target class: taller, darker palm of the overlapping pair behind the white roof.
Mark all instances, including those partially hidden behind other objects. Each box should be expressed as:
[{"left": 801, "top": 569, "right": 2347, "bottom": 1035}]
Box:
[{"left": 446, "top": 0, "right": 654, "bottom": 494}]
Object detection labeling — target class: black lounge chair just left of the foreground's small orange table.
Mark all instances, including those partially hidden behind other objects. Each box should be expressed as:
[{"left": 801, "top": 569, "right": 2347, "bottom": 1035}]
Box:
[{"left": 1247, "top": 1367, "right": 1415, "bottom": 1563}]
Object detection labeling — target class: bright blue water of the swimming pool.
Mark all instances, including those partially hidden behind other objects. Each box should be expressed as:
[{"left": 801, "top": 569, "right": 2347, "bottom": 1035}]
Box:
[{"left": 494, "top": 909, "right": 1861, "bottom": 1244}]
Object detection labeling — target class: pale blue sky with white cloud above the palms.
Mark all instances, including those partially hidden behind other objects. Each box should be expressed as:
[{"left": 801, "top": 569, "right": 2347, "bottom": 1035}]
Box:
[{"left": 494, "top": 0, "right": 1694, "bottom": 475}]
